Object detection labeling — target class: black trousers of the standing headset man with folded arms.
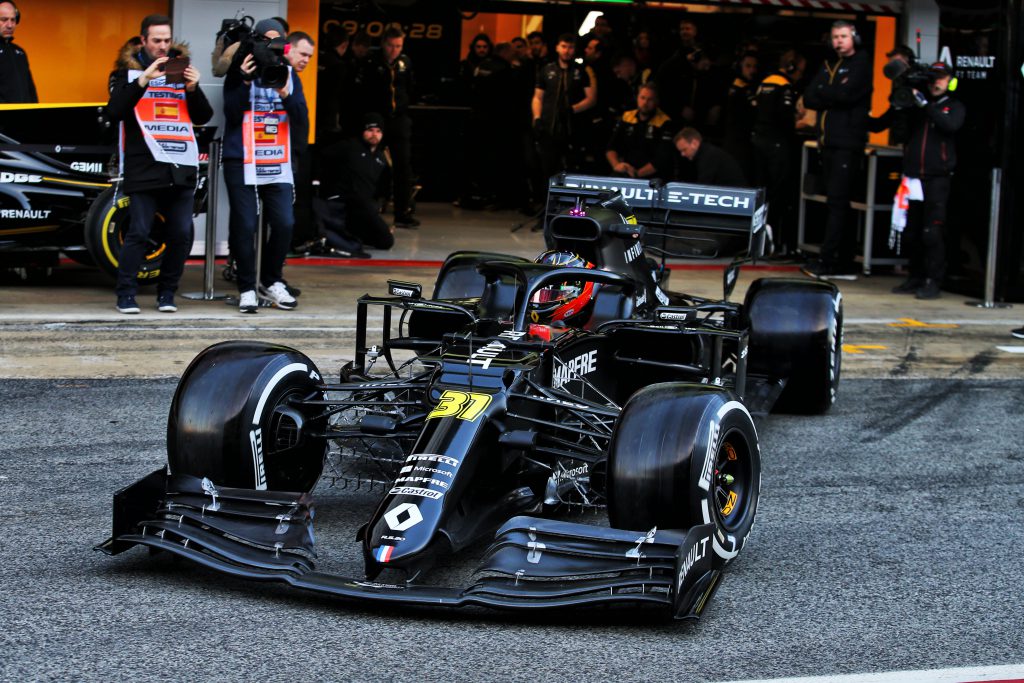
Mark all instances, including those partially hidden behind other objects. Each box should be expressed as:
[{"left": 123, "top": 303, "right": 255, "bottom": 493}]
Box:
[{"left": 821, "top": 147, "right": 863, "bottom": 264}]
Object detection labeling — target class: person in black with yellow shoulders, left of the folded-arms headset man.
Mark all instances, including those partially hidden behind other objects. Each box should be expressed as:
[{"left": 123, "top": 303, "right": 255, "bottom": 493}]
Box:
[{"left": 752, "top": 50, "right": 807, "bottom": 255}]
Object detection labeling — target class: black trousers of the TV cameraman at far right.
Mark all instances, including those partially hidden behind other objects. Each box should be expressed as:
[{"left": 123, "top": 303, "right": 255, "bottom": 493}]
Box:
[{"left": 902, "top": 175, "right": 951, "bottom": 283}]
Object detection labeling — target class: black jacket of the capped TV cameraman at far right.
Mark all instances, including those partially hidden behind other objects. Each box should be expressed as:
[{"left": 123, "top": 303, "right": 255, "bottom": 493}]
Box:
[{"left": 903, "top": 94, "right": 967, "bottom": 178}]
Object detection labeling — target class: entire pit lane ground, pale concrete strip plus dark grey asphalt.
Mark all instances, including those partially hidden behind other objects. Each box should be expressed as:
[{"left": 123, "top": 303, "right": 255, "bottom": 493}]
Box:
[{"left": 0, "top": 209, "right": 1024, "bottom": 681}]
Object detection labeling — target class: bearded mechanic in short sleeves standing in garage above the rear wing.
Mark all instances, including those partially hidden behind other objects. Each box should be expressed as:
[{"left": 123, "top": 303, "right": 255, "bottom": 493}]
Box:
[{"left": 532, "top": 33, "right": 597, "bottom": 189}]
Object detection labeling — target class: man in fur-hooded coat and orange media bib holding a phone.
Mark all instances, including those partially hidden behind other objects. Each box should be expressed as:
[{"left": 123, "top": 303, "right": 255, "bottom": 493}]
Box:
[{"left": 106, "top": 14, "right": 213, "bottom": 313}]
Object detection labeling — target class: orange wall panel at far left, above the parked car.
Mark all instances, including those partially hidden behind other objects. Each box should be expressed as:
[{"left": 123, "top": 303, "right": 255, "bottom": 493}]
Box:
[{"left": 14, "top": 0, "right": 170, "bottom": 102}]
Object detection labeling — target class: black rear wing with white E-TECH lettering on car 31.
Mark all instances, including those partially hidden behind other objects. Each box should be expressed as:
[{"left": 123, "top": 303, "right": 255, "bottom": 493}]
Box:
[{"left": 544, "top": 173, "right": 769, "bottom": 258}]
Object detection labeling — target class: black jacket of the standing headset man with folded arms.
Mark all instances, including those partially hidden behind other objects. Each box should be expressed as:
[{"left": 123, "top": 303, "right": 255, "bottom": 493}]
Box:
[{"left": 804, "top": 50, "right": 871, "bottom": 150}]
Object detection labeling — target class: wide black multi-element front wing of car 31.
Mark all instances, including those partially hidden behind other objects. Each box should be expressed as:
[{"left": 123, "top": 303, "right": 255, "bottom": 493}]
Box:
[{"left": 96, "top": 470, "right": 721, "bottom": 618}]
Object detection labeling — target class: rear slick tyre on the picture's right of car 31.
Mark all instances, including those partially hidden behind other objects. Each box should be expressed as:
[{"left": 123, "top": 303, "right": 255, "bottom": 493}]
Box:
[{"left": 742, "top": 278, "right": 843, "bottom": 415}]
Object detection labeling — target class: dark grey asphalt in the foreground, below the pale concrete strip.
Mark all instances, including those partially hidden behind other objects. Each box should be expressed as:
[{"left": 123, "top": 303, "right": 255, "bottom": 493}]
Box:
[{"left": 0, "top": 379, "right": 1024, "bottom": 681}]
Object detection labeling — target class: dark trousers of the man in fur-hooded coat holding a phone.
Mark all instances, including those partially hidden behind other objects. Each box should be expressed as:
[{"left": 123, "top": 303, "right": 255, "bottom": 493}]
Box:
[{"left": 116, "top": 187, "right": 196, "bottom": 296}]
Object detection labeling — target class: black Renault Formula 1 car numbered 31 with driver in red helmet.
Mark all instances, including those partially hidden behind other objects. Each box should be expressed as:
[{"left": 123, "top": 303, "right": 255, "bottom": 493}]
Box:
[{"left": 97, "top": 177, "right": 843, "bottom": 618}]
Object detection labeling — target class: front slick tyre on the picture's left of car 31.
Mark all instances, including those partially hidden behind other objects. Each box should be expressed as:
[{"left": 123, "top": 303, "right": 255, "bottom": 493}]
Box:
[{"left": 167, "top": 341, "right": 327, "bottom": 492}]
